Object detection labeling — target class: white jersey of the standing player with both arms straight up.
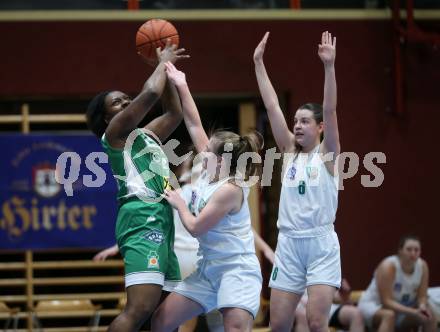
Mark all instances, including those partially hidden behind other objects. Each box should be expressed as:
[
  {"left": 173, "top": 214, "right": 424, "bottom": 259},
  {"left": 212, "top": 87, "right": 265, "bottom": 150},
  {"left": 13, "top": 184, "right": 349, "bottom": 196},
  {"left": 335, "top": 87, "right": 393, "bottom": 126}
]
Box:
[{"left": 277, "top": 145, "right": 338, "bottom": 237}]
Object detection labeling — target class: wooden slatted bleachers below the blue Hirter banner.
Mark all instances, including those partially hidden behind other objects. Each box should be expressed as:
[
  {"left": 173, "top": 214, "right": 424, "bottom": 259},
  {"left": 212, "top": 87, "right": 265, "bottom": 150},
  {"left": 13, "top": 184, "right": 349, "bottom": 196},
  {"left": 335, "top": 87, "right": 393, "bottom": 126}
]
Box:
[{"left": 0, "top": 251, "right": 125, "bottom": 332}]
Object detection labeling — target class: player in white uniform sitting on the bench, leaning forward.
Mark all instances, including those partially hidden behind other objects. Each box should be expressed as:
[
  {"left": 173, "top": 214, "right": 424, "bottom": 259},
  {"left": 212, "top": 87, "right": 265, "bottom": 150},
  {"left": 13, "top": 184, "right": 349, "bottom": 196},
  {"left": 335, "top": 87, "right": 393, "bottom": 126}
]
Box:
[{"left": 358, "top": 236, "right": 436, "bottom": 332}]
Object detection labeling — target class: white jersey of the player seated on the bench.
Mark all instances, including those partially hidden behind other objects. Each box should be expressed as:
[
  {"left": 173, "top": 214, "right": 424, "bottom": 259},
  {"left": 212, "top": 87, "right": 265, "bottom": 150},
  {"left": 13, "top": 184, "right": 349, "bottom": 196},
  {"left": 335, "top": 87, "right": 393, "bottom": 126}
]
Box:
[{"left": 362, "top": 255, "right": 423, "bottom": 306}]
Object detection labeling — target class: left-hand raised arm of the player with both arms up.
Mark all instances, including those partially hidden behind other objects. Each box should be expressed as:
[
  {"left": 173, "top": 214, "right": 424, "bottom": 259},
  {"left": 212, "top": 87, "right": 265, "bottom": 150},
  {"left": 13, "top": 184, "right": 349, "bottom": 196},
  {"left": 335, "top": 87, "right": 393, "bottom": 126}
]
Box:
[{"left": 254, "top": 32, "right": 295, "bottom": 152}]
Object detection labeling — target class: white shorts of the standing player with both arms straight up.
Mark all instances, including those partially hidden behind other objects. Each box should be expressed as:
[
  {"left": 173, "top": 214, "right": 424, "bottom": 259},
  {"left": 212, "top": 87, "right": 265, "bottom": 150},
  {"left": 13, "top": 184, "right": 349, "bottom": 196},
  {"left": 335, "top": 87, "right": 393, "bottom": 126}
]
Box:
[{"left": 269, "top": 231, "right": 341, "bottom": 295}]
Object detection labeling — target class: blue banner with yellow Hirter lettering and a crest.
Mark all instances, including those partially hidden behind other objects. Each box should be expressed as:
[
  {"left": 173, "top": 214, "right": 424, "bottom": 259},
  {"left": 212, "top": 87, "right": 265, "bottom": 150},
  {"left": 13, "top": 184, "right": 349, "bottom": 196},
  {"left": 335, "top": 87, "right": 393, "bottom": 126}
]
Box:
[{"left": 0, "top": 134, "right": 117, "bottom": 250}]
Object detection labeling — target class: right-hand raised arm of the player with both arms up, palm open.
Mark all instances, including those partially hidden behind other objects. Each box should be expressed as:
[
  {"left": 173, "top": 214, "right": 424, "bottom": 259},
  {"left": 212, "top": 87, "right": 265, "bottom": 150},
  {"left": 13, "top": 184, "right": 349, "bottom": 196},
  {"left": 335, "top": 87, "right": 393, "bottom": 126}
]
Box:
[{"left": 318, "top": 31, "right": 341, "bottom": 160}]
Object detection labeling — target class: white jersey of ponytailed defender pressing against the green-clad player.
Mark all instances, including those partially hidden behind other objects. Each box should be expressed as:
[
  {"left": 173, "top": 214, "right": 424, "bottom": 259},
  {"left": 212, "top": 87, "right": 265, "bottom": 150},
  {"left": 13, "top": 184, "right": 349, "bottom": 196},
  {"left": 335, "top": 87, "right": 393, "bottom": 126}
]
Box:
[{"left": 190, "top": 172, "right": 255, "bottom": 259}]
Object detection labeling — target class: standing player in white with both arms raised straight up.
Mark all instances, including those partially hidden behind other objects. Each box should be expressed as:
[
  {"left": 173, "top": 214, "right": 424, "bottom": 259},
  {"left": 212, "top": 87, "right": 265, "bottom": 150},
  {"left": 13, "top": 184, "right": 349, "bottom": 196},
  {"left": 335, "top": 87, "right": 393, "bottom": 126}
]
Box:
[{"left": 254, "top": 32, "right": 341, "bottom": 332}]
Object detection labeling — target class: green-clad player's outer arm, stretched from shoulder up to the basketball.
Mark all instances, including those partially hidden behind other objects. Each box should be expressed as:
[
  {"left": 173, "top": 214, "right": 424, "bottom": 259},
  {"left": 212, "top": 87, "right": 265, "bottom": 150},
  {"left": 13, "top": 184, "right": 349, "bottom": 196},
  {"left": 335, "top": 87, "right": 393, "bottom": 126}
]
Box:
[{"left": 105, "top": 42, "right": 187, "bottom": 148}]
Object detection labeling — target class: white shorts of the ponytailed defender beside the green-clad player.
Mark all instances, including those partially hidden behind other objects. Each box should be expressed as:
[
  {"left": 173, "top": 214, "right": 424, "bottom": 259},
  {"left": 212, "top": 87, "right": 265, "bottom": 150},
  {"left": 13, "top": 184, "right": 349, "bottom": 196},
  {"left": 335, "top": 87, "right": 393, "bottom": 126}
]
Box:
[{"left": 174, "top": 254, "right": 262, "bottom": 318}]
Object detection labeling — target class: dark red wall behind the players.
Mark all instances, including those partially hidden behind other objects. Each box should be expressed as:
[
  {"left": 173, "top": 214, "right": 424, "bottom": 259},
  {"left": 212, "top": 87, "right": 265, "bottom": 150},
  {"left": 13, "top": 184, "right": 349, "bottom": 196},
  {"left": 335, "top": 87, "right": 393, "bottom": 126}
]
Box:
[{"left": 0, "top": 21, "right": 440, "bottom": 288}]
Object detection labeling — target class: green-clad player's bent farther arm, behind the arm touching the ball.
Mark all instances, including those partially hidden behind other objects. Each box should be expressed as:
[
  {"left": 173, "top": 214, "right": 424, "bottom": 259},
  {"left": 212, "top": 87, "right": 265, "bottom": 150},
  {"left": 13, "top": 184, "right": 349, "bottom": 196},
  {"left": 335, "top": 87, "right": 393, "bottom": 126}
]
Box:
[{"left": 145, "top": 80, "right": 183, "bottom": 142}]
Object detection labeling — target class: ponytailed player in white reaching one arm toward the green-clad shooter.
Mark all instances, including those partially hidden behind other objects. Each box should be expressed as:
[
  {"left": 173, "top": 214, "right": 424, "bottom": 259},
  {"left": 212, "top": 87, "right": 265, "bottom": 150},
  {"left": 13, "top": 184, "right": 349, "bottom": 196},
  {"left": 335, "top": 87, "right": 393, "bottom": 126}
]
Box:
[{"left": 152, "top": 63, "right": 262, "bottom": 332}]
